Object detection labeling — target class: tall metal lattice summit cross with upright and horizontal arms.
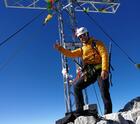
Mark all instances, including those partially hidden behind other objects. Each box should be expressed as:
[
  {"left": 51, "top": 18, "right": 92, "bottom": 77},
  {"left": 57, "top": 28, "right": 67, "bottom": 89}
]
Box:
[{"left": 4, "top": 0, "right": 120, "bottom": 112}]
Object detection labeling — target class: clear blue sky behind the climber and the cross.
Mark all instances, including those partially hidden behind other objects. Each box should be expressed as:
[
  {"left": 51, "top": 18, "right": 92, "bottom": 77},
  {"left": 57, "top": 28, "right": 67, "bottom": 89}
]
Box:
[{"left": 0, "top": 0, "right": 140, "bottom": 124}]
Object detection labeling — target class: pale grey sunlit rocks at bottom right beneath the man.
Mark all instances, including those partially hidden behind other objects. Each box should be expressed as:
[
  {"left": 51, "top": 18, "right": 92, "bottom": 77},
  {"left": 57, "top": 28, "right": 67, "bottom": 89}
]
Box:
[{"left": 68, "top": 97, "right": 140, "bottom": 124}]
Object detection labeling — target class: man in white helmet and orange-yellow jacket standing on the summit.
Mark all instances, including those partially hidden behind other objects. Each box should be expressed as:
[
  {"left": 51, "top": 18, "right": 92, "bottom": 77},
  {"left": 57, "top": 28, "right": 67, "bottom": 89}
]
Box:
[{"left": 54, "top": 27, "right": 112, "bottom": 114}]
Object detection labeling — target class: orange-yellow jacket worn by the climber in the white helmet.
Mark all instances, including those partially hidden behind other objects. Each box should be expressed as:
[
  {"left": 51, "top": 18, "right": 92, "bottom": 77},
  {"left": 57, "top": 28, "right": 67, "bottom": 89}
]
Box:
[{"left": 58, "top": 38, "right": 109, "bottom": 71}]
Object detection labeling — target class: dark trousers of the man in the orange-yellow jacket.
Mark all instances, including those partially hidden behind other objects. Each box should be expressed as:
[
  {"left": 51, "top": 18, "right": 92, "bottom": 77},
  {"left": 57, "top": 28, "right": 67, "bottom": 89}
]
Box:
[{"left": 74, "top": 71, "right": 112, "bottom": 114}]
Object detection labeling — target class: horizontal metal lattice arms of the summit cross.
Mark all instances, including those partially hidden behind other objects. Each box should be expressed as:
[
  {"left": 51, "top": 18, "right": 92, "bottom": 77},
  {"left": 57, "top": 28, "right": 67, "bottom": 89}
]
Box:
[{"left": 4, "top": 0, "right": 120, "bottom": 14}]
